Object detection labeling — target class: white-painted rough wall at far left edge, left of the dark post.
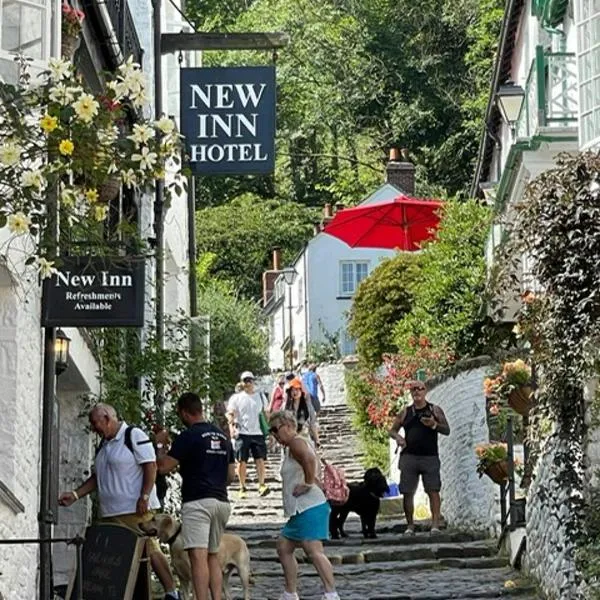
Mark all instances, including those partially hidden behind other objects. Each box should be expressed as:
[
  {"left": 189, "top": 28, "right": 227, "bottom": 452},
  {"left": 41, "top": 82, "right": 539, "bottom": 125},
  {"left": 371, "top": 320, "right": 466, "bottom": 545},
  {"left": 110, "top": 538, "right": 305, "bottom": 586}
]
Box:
[{"left": 0, "top": 267, "right": 42, "bottom": 598}]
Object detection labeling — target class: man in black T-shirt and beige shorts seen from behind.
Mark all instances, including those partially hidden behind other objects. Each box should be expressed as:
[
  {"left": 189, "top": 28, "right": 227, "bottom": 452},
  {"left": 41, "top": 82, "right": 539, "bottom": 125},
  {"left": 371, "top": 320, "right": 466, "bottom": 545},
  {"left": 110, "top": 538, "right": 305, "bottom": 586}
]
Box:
[{"left": 156, "top": 392, "right": 235, "bottom": 600}]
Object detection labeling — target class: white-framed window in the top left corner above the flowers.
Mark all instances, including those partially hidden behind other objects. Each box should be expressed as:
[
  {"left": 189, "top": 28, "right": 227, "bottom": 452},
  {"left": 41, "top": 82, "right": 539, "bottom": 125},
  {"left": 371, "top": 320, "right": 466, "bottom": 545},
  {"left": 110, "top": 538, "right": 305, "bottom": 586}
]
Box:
[{"left": 0, "top": 0, "right": 49, "bottom": 82}]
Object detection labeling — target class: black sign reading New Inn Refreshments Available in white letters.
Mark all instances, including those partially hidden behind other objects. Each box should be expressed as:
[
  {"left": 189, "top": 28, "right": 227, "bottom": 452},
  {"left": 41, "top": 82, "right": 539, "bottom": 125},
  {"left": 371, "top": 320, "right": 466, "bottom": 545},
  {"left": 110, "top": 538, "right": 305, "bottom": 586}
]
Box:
[{"left": 42, "top": 256, "right": 144, "bottom": 327}]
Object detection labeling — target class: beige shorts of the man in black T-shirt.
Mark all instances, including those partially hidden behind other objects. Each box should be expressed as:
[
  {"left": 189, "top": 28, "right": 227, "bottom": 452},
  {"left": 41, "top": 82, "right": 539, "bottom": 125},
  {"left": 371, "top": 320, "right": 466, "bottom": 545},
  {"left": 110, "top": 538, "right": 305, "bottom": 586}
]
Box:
[{"left": 181, "top": 498, "right": 231, "bottom": 554}]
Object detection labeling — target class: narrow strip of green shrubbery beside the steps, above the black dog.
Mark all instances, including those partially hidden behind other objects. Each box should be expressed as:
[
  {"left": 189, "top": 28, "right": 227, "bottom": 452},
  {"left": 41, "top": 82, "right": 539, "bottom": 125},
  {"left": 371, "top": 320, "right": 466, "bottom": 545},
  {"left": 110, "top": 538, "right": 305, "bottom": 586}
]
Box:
[{"left": 346, "top": 371, "right": 390, "bottom": 473}]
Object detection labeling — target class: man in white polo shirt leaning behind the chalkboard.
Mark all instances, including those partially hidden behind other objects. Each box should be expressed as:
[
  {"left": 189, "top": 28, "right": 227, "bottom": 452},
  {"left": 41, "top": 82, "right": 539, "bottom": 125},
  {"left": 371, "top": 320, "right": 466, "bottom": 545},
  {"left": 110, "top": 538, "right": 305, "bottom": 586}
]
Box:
[{"left": 59, "top": 404, "right": 180, "bottom": 600}]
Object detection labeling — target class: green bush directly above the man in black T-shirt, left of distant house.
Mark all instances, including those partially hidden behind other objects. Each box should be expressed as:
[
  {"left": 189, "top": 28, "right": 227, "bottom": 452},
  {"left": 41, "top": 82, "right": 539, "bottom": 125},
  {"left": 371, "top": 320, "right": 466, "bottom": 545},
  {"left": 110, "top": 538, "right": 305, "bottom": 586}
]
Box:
[{"left": 198, "top": 279, "right": 267, "bottom": 403}]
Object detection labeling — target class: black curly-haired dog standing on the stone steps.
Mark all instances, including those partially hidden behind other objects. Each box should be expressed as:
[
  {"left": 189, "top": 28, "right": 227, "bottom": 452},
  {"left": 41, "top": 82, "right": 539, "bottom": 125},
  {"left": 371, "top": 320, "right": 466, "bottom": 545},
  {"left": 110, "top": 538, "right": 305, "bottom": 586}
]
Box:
[{"left": 329, "top": 467, "right": 388, "bottom": 540}]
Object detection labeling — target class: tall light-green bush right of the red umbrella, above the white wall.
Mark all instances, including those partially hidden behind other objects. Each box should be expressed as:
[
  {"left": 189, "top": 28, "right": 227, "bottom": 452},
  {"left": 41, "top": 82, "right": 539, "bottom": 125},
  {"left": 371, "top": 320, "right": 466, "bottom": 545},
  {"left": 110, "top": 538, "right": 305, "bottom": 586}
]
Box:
[{"left": 394, "top": 200, "right": 490, "bottom": 358}]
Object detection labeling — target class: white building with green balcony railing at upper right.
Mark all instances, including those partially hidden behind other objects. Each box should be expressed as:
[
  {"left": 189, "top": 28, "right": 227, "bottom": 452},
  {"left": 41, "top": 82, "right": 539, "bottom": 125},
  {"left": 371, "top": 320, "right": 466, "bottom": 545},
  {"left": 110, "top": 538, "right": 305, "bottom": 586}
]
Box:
[{"left": 471, "top": 0, "right": 580, "bottom": 312}]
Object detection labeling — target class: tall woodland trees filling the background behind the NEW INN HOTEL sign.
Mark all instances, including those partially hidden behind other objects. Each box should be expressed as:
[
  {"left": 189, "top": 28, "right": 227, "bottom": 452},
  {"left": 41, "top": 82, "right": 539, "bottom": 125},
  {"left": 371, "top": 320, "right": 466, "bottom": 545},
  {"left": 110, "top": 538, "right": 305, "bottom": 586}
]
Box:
[{"left": 186, "top": 0, "right": 504, "bottom": 206}]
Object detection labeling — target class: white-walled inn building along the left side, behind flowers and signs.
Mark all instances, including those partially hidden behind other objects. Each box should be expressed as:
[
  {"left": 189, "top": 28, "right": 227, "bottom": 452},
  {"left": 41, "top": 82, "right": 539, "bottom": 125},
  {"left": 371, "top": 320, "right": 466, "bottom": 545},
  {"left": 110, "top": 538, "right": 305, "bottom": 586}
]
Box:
[{"left": 0, "top": 0, "right": 194, "bottom": 600}]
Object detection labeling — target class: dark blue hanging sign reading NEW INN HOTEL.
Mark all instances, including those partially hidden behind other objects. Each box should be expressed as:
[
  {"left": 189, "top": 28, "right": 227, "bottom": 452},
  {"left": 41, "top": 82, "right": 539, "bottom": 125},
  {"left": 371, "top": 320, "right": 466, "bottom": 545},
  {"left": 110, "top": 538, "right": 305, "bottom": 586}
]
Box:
[{"left": 181, "top": 67, "right": 276, "bottom": 175}]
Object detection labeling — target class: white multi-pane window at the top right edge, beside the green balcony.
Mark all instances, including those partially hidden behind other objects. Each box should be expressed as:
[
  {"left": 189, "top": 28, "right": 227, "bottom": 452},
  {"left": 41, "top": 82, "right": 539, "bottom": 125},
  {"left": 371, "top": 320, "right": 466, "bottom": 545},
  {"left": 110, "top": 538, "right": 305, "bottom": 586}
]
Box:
[{"left": 576, "top": 0, "right": 600, "bottom": 146}]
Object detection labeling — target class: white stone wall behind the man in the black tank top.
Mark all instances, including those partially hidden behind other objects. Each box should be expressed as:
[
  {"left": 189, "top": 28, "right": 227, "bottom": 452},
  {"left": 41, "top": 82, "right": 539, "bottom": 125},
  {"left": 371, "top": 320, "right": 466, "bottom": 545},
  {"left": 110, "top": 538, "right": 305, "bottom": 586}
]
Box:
[{"left": 390, "top": 367, "right": 498, "bottom": 532}]
